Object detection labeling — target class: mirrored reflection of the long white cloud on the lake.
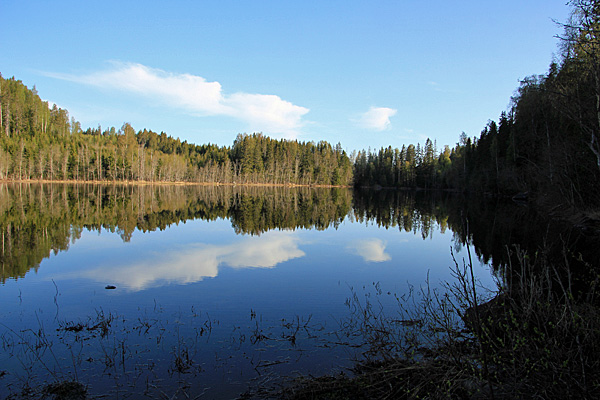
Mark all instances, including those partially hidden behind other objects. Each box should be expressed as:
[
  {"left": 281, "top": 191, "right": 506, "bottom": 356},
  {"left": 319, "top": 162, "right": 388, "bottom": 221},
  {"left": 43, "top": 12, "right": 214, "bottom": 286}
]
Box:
[{"left": 71, "top": 232, "right": 305, "bottom": 291}]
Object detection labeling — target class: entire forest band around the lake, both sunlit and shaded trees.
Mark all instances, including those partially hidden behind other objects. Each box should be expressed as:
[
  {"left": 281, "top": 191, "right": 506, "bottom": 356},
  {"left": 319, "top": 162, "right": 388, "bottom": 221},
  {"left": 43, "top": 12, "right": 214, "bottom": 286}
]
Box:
[{"left": 0, "top": 2, "right": 600, "bottom": 214}]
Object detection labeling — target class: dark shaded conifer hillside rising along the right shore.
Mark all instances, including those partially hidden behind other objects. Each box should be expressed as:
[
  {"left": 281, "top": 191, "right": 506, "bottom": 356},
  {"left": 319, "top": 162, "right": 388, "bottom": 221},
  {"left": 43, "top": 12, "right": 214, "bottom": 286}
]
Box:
[{"left": 355, "top": 1, "right": 600, "bottom": 208}]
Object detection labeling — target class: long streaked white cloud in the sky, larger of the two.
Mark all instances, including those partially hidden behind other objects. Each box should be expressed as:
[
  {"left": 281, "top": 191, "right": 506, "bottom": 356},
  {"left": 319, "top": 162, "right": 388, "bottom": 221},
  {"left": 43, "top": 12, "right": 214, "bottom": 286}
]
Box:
[{"left": 48, "top": 62, "right": 309, "bottom": 138}]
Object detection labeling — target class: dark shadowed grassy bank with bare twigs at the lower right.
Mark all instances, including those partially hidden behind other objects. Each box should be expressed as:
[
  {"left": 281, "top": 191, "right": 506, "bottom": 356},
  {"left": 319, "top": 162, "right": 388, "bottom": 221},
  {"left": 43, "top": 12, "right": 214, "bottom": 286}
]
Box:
[{"left": 255, "top": 247, "right": 600, "bottom": 399}]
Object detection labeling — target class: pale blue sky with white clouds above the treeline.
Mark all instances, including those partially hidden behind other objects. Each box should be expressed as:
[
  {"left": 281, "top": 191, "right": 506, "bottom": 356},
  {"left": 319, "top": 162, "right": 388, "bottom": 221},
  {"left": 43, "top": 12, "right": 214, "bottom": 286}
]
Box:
[{"left": 0, "top": 0, "right": 569, "bottom": 151}]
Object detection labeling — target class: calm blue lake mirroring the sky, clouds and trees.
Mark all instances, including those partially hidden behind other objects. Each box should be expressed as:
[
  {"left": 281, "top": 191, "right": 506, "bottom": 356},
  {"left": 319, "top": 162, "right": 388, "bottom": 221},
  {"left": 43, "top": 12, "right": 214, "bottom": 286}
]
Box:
[{"left": 0, "top": 184, "right": 500, "bottom": 399}]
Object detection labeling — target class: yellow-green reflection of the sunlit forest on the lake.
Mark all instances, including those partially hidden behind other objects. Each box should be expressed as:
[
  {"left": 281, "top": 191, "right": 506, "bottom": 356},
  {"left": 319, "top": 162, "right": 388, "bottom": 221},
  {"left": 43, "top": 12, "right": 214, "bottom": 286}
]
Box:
[{"left": 0, "top": 184, "right": 352, "bottom": 282}]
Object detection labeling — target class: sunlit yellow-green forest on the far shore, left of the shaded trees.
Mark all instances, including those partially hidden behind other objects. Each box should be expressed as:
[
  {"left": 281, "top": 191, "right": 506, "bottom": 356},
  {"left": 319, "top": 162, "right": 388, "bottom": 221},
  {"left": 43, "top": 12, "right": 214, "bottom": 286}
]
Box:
[{"left": 0, "top": 75, "right": 352, "bottom": 185}]
